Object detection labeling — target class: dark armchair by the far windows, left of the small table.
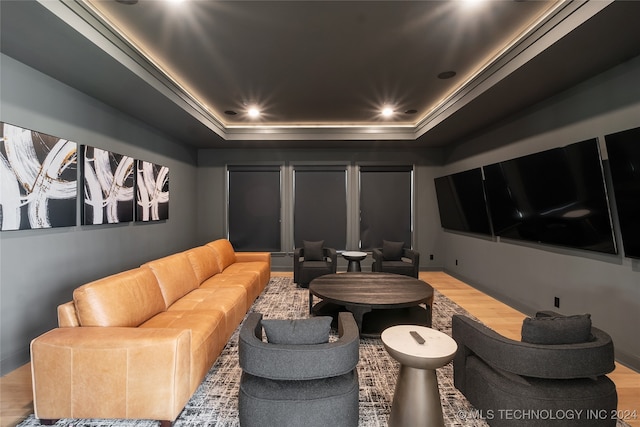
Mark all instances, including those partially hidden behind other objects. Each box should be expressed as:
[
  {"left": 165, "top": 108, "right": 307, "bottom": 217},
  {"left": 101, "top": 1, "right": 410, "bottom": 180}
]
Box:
[{"left": 293, "top": 240, "right": 338, "bottom": 288}]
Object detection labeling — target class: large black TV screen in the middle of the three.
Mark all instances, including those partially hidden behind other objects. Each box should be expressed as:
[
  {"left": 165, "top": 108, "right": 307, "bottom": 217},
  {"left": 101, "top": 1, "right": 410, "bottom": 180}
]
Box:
[{"left": 484, "top": 139, "right": 617, "bottom": 254}]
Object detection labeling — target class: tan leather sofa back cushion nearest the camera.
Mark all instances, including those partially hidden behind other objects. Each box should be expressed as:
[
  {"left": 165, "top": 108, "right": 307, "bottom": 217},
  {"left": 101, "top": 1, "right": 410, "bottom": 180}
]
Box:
[{"left": 73, "top": 268, "right": 165, "bottom": 327}]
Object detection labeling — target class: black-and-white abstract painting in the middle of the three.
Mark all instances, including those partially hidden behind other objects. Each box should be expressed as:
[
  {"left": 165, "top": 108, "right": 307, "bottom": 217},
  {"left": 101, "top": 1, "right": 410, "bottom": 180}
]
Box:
[{"left": 82, "top": 145, "right": 135, "bottom": 225}]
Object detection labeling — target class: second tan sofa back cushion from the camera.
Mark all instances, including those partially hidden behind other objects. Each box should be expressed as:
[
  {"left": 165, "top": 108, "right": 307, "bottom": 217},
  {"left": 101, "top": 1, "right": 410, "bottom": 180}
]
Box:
[{"left": 142, "top": 252, "right": 200, "bottom": 308}]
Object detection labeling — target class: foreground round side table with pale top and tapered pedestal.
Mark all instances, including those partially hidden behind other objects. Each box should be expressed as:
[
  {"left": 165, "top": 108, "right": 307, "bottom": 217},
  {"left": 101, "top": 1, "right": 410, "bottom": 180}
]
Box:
[{"left": 381, "top": 325, "right": 458, "bottom": 427}]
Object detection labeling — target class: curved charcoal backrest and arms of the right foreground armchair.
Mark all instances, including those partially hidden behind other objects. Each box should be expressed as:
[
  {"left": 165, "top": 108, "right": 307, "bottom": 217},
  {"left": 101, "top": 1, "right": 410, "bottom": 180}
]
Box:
[{"left": 452, "top": 315, "right": 615, "bottom": 379}]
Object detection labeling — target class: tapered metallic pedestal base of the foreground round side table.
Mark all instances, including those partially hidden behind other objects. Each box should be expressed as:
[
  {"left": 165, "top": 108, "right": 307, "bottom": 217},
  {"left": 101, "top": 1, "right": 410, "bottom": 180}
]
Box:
[{"left": 389, "top": 365, "right": 444, "bottom": 427}]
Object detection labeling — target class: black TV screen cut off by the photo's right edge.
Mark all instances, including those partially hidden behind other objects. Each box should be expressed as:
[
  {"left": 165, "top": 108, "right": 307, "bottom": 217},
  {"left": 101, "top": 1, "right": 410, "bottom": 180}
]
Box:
[{"left": 605, "top": 128, "right": 640, "bottom": 258}]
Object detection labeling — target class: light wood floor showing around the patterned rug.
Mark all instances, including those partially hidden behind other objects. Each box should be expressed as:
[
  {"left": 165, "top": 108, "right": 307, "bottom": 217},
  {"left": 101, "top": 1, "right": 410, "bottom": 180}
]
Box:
[{"left": 0, "top": 272, "right": 640, "bottom": 427}]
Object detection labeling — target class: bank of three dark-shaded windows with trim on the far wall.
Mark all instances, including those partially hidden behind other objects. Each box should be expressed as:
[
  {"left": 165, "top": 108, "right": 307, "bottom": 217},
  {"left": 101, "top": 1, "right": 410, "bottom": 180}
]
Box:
[{"left": 227, "top": 164, "right": 413, "bottom": 253}]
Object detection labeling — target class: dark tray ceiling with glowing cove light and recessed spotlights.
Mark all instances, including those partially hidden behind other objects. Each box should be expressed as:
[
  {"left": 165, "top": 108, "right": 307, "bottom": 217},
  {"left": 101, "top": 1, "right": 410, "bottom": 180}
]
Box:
[{"left": 0, "top": 0, "right": 640, "bottom": 148}]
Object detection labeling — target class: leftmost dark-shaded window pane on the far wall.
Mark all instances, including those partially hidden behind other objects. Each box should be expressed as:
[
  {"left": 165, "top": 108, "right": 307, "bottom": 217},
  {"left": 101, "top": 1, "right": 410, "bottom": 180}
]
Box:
[{"left": 228, "top": 166, "right": 281, "bottom": 252}]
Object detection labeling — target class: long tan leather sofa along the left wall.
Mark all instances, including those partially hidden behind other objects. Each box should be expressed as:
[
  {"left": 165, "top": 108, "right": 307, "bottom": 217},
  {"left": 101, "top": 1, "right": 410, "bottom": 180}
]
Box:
[{"left": 31, "top": 239, "right": 271, "bottom": 425}]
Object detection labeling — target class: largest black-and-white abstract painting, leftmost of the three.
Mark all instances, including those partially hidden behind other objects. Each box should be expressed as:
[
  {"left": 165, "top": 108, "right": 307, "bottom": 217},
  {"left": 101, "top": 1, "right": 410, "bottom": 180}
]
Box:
[{"left": 0, "top": 122, "right": 78, "bottom": 231}]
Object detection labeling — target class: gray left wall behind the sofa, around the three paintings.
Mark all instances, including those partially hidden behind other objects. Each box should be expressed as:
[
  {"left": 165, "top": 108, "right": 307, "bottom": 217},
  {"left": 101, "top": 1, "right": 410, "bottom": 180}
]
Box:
[{"left": 0, "top": 55, "right": 197, "bottom": 374}]
